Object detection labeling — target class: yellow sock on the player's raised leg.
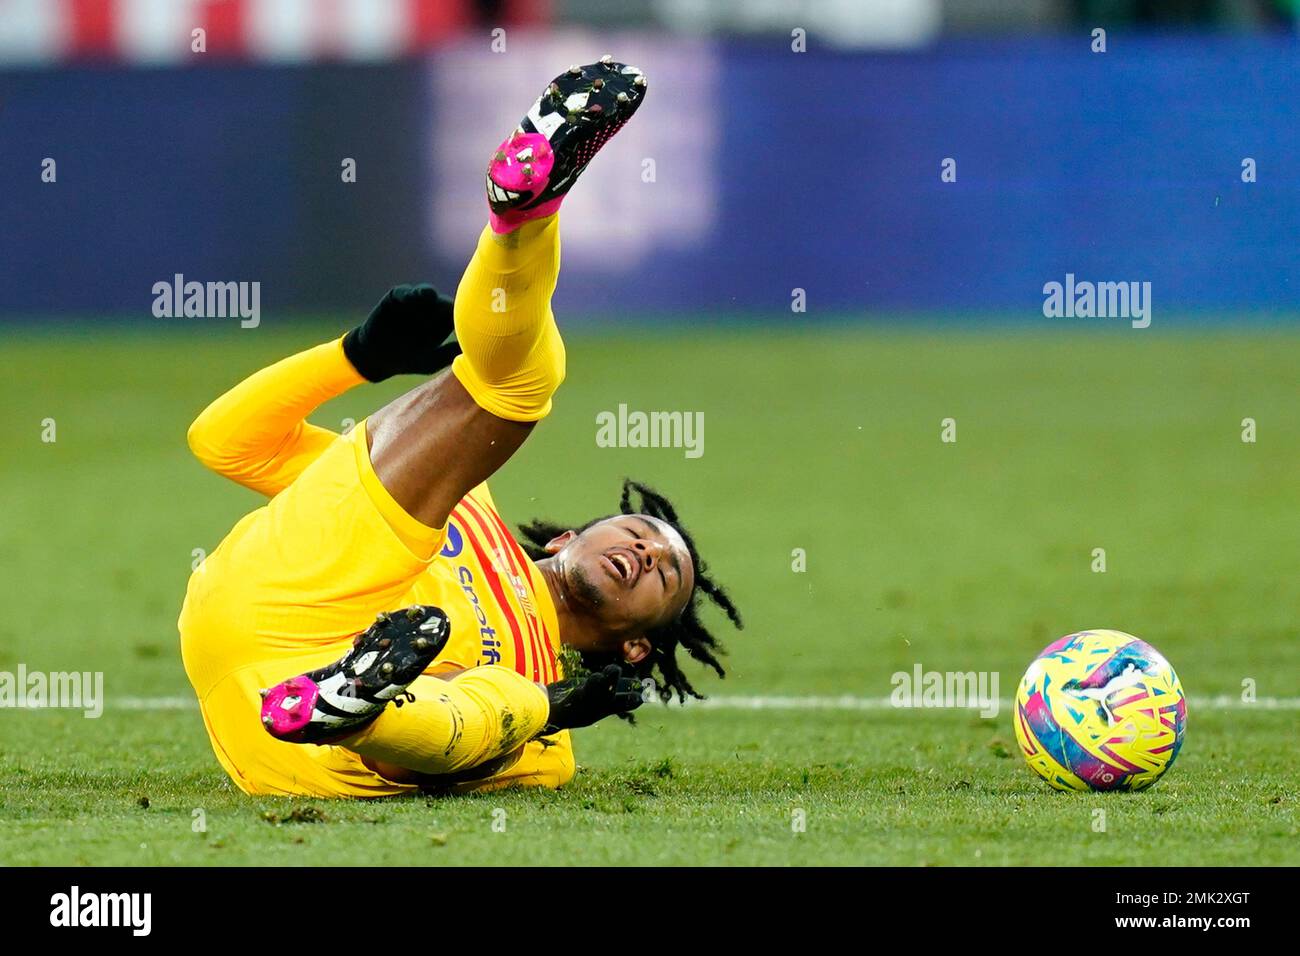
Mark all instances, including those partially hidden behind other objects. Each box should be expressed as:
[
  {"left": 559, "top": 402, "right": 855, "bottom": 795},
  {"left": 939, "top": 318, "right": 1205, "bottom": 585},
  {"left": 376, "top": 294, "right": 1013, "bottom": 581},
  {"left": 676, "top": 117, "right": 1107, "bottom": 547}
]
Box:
[{"left": 451, "top": 216, "right": 564, "bottom": 421}]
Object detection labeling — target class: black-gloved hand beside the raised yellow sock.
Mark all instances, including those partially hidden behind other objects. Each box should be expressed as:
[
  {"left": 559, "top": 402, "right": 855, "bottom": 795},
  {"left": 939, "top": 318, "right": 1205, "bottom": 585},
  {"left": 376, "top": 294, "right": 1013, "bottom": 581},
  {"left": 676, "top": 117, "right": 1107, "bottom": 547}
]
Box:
[{"left": 343, "top": 282, "right": 460, "bottom": 381}]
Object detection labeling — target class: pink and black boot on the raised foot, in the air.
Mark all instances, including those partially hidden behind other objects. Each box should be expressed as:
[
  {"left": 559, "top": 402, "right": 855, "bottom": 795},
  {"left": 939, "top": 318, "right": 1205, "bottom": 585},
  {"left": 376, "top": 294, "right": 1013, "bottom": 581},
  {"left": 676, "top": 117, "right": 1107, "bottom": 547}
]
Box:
[{"left": 488, "top": 55, "right": 646, "bottom": 233}]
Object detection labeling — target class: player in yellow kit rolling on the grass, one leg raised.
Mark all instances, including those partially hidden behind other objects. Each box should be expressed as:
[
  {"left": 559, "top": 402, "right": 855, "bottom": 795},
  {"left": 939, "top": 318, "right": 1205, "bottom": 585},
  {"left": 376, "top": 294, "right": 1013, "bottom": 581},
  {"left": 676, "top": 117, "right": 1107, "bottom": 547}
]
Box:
[{"left": 179, "top": 57, "right": 740, "bottom": 796}]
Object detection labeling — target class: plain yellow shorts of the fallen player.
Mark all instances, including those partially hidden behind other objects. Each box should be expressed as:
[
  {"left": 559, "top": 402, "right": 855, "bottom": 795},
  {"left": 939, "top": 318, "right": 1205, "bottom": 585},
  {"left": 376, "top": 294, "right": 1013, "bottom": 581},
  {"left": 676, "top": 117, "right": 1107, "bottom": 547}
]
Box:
[{"left": 179, "top": 421, "right": 439, "bottom": 797}]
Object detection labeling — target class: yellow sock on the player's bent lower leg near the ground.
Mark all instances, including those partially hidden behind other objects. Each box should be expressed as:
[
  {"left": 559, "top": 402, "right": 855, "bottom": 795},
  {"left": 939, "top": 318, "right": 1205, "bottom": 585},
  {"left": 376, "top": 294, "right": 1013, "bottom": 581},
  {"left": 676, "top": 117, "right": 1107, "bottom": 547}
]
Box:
[{"left": 343, "top": 666, "right": 550, "bottom": 774}]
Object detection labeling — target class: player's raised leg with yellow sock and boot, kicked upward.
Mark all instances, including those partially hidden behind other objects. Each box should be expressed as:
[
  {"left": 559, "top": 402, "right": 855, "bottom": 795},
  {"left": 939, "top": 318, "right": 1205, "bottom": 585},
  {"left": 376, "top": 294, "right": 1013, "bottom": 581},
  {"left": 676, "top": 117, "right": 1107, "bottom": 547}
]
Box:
[{"left": 367, "top": 57, "right": 646, "bottom": 527}]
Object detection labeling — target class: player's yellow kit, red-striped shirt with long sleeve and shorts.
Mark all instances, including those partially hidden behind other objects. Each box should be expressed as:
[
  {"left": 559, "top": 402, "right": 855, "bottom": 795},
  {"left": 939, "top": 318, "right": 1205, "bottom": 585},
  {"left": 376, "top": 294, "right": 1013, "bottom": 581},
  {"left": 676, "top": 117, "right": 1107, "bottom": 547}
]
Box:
[{"left": 179, "top": 342, "right": 576, "bottom": 796}]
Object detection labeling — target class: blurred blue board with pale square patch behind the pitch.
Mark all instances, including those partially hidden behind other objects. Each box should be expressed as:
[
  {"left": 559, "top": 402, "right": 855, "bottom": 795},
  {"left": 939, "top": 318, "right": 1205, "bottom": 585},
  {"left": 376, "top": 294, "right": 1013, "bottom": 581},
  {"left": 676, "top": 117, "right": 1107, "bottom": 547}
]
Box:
[{"left": 0, "top": 0, "right": 1300, "bottom": 317}]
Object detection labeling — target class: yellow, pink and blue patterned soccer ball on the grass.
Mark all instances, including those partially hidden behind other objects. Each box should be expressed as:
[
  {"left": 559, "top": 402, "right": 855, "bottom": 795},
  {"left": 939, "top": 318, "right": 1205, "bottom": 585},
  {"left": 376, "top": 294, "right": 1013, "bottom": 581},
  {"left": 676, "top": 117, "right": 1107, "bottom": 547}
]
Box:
[{"left": 1013, "top": 631, "right": 1187, "bottom": 791}]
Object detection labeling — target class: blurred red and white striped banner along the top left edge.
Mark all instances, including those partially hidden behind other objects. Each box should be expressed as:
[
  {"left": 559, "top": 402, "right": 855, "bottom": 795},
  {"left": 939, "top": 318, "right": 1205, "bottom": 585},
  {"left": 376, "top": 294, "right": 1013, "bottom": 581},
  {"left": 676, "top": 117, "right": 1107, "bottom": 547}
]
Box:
[{"left": 0, "top": 0, "right": 547, "bottom": 66}]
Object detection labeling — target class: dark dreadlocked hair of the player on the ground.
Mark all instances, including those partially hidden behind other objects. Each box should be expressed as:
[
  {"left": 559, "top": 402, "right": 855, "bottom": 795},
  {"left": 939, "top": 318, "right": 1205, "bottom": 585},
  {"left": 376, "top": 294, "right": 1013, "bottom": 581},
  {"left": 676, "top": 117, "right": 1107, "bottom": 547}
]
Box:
[{"left": 519, "top": 479, "right": 744, "bottom": 702}]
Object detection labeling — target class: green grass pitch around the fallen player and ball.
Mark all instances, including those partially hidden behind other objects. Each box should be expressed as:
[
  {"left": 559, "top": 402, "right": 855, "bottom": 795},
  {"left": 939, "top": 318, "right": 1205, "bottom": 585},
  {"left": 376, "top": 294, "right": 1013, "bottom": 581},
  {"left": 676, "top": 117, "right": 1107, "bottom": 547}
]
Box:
[{"left": 0, "top": 321, "right": 1300, "bottom": 865}]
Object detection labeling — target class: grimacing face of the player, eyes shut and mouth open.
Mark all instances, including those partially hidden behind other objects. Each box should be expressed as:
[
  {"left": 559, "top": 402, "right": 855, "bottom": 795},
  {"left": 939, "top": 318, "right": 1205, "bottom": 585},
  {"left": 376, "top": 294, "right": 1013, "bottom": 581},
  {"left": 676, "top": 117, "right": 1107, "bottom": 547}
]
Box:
[{"left": 556, "top": 515, "right": 696, "bottom": 636}]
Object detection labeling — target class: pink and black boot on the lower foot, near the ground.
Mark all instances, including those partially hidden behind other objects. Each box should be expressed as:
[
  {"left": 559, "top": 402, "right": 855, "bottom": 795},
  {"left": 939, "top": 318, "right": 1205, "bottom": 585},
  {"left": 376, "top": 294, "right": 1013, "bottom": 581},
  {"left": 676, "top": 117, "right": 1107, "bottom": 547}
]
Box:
[{"left": 261, "top": 605, "right": 451, "bottom": 744}]
